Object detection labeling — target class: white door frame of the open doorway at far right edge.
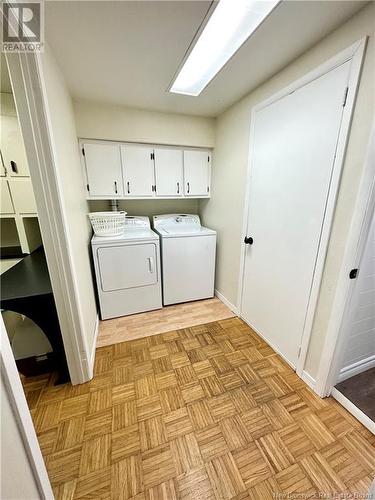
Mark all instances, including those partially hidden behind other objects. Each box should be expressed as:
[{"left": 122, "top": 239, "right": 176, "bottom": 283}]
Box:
[{"left": 315, "top": 121, "right": 375, "bottom": 397}]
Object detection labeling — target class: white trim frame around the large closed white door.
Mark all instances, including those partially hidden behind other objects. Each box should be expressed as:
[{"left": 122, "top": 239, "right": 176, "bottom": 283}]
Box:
[{"left": 237, "top": 37, "right": 367, "bottom": 378}]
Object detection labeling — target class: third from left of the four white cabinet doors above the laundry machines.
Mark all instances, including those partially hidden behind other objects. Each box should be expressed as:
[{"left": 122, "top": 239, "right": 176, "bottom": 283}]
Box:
[{"left": 154, "top": 148, "right": 183, "bottom": 197}]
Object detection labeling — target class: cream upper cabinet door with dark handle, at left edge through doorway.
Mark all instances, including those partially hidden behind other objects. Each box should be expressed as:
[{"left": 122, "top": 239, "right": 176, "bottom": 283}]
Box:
[{"left": 0, "top": 115, "right": 30, "bottom": 177}]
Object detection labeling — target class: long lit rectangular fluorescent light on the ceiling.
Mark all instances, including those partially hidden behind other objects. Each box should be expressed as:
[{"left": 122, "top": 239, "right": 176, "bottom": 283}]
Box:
[{"left": 170, "top": 0, "right": 280, "bottom": 96}]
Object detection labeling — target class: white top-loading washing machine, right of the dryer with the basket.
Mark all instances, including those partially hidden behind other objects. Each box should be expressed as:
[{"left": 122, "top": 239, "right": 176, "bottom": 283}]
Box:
[{"left": 153, "top": 214, "right": 216, "bottom": 305}]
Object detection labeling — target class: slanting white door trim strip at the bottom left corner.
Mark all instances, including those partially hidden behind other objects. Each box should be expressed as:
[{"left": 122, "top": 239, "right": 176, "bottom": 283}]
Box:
[{"left": 0, "top": 314, "right": 54, "bottom": 500}]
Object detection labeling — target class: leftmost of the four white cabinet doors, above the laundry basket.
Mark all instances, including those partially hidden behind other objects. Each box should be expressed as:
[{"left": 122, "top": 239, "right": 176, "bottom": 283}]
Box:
[{"left": 83, "top": 144, "right": 124, "bottom": 198}]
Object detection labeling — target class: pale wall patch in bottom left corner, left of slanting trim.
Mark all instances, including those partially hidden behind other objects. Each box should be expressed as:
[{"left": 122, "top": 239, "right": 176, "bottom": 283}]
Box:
[{"left": 0, "top": 379, "right": 40, "bottom": 500}]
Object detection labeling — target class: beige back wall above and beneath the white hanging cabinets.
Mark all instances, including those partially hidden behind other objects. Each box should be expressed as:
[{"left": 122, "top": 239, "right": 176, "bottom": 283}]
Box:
[{"left": 74, "top": 101, "right": 215, "bottom": 216}]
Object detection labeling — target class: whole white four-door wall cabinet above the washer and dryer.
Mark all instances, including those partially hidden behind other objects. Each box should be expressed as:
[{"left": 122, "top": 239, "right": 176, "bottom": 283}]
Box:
[{"left": 80, "top": 141, "right": 211, "bottom": 199}]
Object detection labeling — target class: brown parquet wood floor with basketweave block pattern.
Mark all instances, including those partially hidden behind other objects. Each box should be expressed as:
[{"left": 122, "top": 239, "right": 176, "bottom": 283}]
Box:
[{"left": 25, "top": 318, "right": 375, "bottom": 500}]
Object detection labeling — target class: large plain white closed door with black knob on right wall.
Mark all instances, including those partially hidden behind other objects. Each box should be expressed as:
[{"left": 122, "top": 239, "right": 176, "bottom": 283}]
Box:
[{"left": 241, "top": 62, "right": 350, "bottom": 366}]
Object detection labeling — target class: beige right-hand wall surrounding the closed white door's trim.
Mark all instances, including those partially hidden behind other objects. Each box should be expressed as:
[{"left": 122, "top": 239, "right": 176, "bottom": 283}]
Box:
[{"left": 199, "top": 3, "right": 375, "bottom": 377}]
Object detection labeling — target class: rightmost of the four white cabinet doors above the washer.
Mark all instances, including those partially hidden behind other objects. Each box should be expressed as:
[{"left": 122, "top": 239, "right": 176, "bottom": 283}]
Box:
[{"left": 184, "top": 151, "right": 211, "bottom": 197}]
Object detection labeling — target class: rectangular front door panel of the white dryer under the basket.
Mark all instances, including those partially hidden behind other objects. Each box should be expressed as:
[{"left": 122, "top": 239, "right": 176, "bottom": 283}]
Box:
[{"left": 97, "top": 243, "right": 158, "bottom": 292}]
